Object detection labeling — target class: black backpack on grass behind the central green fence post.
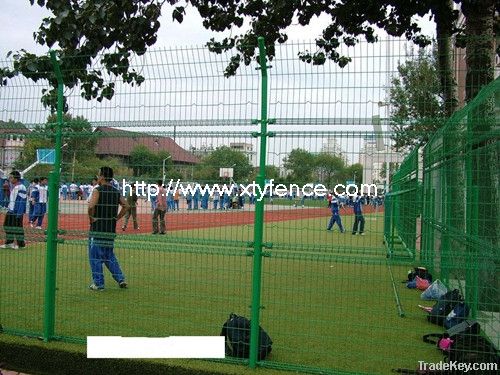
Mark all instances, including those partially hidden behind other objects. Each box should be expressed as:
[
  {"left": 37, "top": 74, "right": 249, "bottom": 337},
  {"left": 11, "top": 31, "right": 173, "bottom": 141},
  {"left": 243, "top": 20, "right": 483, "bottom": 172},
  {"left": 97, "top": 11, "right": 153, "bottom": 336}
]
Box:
[{"left": 220, "top": 313, "right": 273, "bottom": 361}]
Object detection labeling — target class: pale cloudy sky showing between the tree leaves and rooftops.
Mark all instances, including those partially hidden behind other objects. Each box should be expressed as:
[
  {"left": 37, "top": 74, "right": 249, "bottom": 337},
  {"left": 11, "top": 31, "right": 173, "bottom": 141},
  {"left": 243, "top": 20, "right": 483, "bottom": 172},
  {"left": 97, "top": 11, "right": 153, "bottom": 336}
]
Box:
[{"left": 0, "top": 0, "right": 434, "bottom": 166}]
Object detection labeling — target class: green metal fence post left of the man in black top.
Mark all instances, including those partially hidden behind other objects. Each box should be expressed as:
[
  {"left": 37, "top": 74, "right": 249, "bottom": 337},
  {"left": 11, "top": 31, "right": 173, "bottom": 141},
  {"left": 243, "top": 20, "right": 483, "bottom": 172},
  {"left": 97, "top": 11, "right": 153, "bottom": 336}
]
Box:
[{"left": 43, "top": 51, "right": 64, "bottom": 341}]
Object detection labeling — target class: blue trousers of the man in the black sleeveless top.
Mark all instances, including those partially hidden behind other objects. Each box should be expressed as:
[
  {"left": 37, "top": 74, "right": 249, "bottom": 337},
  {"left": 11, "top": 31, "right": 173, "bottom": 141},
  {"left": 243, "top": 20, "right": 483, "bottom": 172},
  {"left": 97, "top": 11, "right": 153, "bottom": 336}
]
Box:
[{"left": 89, "top": 237, "right": 125, "bottom": 288}]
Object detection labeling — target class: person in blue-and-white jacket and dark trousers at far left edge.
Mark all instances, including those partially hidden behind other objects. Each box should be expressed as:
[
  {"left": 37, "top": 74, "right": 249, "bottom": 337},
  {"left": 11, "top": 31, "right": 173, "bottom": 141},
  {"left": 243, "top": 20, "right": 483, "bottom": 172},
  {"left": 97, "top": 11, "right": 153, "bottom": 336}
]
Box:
[{"left": 0, "top": 171, "right": 27, "bottom": 249}]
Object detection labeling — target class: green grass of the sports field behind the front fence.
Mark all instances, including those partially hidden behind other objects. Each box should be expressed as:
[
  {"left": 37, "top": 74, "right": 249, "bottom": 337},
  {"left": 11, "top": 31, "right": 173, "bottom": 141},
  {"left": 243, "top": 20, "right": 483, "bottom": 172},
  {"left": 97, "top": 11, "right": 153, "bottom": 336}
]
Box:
[{"left": 0, "top": 214, "right": 441, "bottom": 374}]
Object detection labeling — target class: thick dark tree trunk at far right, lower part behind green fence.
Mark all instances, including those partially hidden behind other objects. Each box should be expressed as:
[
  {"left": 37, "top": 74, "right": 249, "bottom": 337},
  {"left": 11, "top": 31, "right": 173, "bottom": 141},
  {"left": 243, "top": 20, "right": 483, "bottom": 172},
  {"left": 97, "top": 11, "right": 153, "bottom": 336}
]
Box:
[{"left": 462, "top": 0, "right": 500, "bottom": 310}]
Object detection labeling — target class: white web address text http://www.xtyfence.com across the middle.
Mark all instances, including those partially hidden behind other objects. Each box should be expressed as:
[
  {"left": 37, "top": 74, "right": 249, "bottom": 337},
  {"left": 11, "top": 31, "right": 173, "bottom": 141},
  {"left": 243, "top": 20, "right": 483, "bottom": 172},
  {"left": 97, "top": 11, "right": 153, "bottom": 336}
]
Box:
[{"left": 122, "top": 179, "right": 377, "bottom": 201}]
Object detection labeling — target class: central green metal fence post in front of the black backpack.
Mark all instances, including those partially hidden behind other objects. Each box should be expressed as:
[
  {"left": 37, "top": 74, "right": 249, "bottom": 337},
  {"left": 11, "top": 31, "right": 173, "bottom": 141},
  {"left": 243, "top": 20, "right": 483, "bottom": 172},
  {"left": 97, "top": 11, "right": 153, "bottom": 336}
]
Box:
[{"left": 249, "top": 37, "right": 268, "bottom": 368}]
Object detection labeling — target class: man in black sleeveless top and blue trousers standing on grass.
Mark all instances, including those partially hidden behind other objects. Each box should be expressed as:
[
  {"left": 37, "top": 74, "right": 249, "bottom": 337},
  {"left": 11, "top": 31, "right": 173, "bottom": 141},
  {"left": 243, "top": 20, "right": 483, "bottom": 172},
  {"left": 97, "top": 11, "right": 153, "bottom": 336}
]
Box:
[{"left": 88, "top": 167, "right": 128, "bottom": 290}]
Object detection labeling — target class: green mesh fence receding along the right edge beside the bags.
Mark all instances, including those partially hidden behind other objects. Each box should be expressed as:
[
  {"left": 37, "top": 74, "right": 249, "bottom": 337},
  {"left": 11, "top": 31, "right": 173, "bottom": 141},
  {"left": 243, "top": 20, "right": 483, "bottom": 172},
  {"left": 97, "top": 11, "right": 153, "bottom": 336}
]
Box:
[{"left": 423, "top": 79, "right": 500, "bottom": 345}]
